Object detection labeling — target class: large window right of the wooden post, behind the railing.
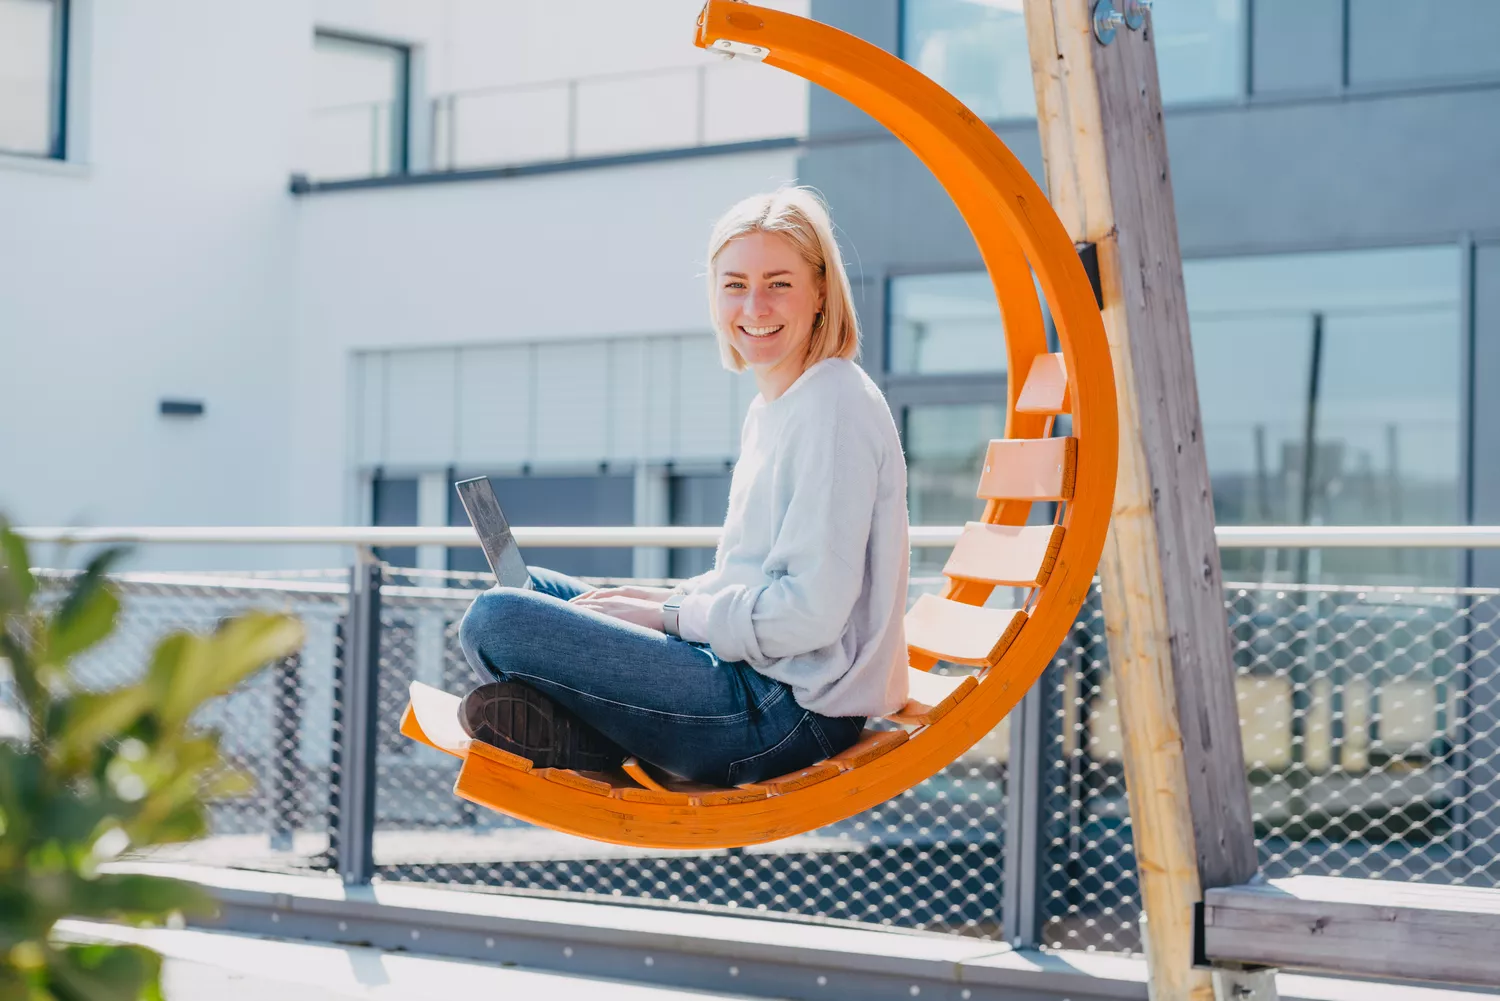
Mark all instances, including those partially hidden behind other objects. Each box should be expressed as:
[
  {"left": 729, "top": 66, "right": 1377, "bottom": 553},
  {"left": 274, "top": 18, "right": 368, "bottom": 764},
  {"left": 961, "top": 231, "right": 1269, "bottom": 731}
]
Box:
[{"left": 1184, "top": 246, "right": 1463, "bottom": 584}]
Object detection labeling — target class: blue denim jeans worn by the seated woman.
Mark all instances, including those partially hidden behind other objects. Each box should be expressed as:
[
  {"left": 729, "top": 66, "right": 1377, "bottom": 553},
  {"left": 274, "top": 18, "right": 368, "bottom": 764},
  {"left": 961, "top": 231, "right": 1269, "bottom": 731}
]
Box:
[{"left": 459, "top": 567, "right": 866, "bottom": 786}]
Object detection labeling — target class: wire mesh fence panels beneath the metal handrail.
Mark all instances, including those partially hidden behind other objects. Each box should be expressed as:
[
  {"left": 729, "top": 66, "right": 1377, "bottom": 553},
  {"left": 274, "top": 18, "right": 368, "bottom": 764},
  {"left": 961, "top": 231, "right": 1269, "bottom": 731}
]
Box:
[{"left": 11, "top": 561, "right": 1500, "bottom": 951}]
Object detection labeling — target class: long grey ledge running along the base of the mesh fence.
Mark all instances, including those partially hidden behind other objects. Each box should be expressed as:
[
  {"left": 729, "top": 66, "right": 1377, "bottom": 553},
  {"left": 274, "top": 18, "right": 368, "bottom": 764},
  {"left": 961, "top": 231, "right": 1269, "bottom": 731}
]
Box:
[{"left": 123, "top": 863, "right": 1490, "bottom": 1001}]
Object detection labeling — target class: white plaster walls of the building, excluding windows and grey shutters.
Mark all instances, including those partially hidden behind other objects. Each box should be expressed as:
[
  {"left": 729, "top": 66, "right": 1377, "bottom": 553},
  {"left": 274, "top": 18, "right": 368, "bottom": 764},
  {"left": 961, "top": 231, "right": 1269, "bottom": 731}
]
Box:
[{"left": 0, "top": 0, "right": 806, "bottom": 567}]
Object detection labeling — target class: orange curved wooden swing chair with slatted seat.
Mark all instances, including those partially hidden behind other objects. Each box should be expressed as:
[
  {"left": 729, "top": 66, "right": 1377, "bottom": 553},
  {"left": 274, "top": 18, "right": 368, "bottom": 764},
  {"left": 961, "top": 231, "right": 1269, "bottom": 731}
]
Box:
[{"left": 402, "top": 0, "right": 1119, "bottom": 848}]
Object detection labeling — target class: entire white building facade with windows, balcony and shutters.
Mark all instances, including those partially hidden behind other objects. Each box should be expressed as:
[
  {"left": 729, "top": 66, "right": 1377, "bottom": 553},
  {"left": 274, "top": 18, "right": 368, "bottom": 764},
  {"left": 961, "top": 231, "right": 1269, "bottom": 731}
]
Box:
[{"left": 0, "top": 0, "right": 807, "bottom": 575}]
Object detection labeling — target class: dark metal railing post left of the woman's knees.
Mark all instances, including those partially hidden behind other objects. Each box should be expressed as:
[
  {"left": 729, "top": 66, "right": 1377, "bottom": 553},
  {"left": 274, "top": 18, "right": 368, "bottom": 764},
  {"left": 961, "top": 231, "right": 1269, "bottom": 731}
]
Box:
[{"left": 333, "top": 558, "right": 381, "bottom": 885}]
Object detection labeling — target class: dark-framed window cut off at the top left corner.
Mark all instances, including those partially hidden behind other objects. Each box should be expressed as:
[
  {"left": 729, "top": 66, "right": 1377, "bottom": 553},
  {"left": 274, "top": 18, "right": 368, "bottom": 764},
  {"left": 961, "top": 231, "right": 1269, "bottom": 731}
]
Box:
[{"left": 0, "top": 0, "right": 68, "bottom": 159}]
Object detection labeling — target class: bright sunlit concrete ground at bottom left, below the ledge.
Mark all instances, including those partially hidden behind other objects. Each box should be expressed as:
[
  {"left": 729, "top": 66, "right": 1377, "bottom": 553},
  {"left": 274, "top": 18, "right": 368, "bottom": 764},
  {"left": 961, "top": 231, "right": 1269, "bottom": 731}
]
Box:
[{"left": 59, "top": 921, "right": 762, "bottom": 1001}]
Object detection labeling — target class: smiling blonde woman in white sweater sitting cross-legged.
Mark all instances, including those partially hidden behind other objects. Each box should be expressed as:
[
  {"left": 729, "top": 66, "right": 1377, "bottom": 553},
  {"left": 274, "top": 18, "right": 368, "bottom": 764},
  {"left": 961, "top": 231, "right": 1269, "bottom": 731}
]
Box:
[{"left": 459, "top": 188, "right": 911, "bottom": 785}]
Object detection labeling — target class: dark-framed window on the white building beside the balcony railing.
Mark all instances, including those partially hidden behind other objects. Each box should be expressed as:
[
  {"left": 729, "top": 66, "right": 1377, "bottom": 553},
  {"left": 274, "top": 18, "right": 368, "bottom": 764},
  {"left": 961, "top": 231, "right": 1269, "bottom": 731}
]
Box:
[{"left": 308, "top": 30, "right": 411, "bottom": 180}]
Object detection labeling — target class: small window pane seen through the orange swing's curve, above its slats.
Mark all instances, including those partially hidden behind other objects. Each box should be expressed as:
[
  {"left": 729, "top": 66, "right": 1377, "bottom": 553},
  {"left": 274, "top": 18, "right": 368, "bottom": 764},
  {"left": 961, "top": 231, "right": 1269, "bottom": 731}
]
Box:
[{"left": 887, "top": 272, "right": 1007, "bottom": 375}]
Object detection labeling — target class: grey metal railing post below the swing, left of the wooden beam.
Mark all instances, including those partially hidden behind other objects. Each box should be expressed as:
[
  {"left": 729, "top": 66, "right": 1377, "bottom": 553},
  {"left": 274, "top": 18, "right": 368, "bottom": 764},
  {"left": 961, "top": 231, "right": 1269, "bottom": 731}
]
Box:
[{"left": 1001, "top": 681, "right": 1053, "bottom": 948}]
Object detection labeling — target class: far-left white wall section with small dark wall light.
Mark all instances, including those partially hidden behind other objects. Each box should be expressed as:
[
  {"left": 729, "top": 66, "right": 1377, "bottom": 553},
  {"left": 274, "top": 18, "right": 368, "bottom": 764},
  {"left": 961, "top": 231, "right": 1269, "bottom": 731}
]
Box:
[{"left": 0, "top": 0, "right": 308, "bottom": 567}]
